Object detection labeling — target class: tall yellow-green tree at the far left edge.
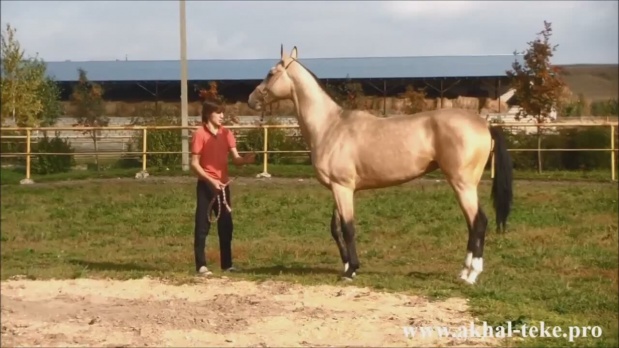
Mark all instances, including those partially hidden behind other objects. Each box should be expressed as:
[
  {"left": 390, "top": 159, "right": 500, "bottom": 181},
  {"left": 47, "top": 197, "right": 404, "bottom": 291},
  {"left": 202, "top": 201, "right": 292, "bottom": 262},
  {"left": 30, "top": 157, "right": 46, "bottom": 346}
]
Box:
[{"left": 0, "top": 24, "right": 62, "bottom": 127}]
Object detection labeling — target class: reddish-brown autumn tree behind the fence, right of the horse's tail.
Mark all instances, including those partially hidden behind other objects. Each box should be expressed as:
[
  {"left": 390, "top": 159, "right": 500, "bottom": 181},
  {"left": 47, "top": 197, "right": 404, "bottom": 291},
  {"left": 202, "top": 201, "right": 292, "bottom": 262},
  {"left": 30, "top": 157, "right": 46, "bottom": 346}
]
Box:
[{"left": 507, "top": 21, "right": 566, "bottom": 173}]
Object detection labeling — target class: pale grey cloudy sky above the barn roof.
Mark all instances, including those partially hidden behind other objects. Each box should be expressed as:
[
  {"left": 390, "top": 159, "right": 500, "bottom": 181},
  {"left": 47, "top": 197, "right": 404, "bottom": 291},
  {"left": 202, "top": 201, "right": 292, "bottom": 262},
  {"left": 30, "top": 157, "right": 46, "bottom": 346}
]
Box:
[{"left": 0, "top": 0, "right": 619, "bottom": 64}]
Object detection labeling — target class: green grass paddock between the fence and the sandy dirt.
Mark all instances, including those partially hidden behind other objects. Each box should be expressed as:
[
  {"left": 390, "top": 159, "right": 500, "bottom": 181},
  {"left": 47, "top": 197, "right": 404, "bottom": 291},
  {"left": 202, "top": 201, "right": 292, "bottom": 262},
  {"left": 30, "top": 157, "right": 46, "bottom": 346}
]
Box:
[{"left": 1, "top": 177, "right": 619, "bottom": 347}]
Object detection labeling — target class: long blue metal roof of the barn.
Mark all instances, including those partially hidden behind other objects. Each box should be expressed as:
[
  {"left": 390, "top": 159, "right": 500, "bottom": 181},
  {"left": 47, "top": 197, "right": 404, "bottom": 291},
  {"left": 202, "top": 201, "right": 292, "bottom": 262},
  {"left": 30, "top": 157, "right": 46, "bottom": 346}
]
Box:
[{"left": 40, "top": 55, "right": 522, "bottom": 82}]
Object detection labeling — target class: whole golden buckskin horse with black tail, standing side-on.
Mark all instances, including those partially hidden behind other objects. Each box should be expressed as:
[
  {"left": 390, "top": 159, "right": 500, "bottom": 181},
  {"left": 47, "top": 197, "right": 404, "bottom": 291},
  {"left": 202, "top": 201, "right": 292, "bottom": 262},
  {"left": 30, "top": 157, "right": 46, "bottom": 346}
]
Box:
[{"left": 247, "top": 45, "right": 513, "bottom": 284}]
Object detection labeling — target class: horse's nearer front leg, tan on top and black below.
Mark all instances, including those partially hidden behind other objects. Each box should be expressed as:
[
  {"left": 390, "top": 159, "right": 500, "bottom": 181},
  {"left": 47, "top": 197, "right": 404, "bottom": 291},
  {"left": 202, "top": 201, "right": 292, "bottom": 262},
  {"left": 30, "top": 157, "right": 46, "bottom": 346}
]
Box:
[{"left": 331, "top": 185, "right": 359, "bottom": 280}]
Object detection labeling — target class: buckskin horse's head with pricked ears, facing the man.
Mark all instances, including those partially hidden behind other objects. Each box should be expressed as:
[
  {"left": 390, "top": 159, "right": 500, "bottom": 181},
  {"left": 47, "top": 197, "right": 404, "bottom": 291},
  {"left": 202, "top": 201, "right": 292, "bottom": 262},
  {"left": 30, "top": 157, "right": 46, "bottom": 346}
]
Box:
[{"left": 247, "top": 45, "right": 297, "bottom": 110}]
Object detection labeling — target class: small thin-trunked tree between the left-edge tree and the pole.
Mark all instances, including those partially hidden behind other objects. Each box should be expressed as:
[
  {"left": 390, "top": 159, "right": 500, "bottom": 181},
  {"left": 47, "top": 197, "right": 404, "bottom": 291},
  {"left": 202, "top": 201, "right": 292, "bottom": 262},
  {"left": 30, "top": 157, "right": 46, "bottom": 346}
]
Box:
[{"left": 71, "top": 69, "right": 110, "bottom": 171}]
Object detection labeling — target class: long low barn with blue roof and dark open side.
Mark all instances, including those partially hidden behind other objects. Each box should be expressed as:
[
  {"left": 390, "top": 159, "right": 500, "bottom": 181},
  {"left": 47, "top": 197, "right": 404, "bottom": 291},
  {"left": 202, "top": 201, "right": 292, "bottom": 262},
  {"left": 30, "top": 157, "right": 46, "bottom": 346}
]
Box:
[{"left": 47, "top": 54, "right": 523, "bottom": 114}]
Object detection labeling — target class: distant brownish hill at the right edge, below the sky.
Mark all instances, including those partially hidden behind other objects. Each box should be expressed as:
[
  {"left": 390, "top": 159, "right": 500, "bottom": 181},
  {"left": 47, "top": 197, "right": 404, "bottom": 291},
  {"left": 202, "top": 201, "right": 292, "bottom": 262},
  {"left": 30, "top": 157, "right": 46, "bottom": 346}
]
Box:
[{"left": 557, "top": 64, "right": 619, "bottom": 101}]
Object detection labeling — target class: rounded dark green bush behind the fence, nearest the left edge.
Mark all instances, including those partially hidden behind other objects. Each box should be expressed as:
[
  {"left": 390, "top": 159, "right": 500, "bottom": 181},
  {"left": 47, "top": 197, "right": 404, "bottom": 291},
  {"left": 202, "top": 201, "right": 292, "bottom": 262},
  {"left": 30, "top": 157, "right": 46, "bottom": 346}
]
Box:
[{"left": 32, "top": 133, "right": 75, "bottom": 175}]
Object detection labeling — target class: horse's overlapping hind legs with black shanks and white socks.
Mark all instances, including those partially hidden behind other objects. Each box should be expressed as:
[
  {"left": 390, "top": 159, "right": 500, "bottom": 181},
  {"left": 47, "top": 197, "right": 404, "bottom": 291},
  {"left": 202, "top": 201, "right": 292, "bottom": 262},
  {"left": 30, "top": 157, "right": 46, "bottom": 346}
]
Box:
[{"left": 450, "top": 182, "right": 488, "bottom": 284}]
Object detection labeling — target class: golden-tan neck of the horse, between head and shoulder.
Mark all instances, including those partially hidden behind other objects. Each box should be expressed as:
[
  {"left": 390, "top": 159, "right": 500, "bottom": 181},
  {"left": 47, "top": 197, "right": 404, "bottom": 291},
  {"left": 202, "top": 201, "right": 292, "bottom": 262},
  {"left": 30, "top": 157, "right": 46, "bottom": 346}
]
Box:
[{"left": 291, "top": 68, "right": 340, "bottom": 147}]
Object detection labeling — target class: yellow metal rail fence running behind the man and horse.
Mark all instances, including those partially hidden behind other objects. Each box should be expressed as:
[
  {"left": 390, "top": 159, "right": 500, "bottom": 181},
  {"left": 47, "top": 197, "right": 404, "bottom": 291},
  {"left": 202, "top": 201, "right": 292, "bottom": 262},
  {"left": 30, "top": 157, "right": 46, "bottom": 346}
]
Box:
[{"left": 0, "top": 121, "right": 618, "bottom": 181}]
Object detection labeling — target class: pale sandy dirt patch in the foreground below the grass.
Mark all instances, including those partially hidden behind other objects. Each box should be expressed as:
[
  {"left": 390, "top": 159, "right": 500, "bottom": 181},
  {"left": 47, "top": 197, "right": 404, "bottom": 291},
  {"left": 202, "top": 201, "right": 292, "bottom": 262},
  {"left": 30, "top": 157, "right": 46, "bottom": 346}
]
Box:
[{"left": 2, "top": 278, "right": 497, "bottom": 347}]
